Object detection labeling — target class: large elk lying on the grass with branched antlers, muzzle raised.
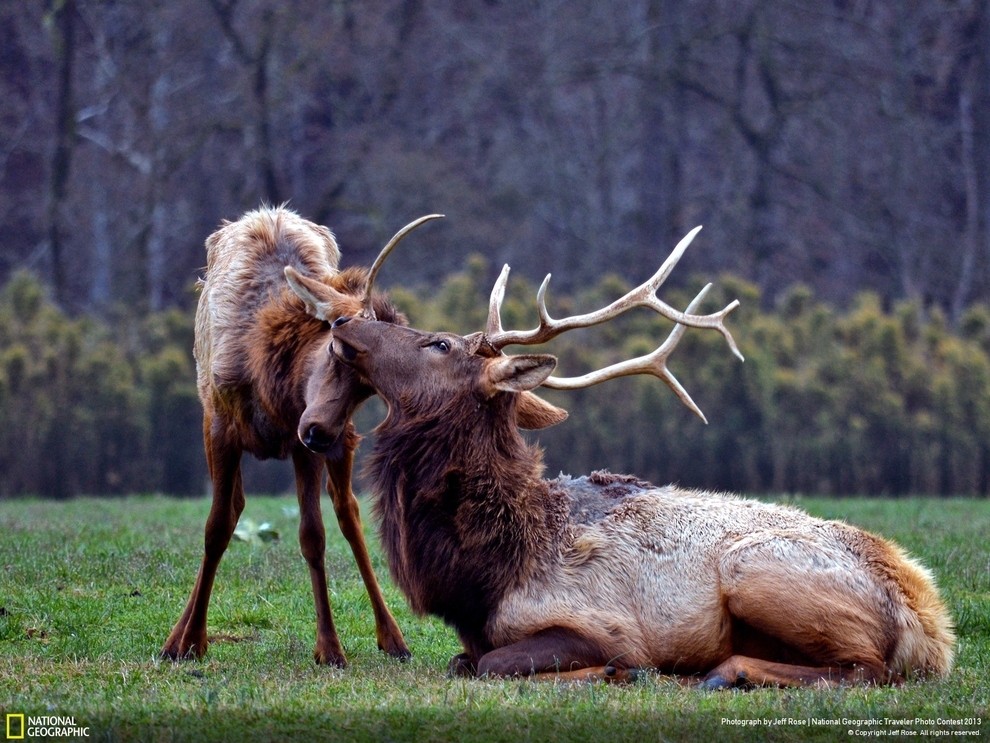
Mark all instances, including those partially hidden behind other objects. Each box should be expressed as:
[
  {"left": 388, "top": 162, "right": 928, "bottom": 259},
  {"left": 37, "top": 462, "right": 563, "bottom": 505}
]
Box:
[{"left": 312, "top": 230, "right": 954, "bottom": 688}]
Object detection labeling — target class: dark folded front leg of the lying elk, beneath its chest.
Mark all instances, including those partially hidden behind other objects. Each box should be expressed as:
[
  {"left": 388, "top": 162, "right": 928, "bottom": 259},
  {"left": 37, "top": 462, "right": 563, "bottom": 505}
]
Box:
[{"left": 478, "top": 627, "right": 621, "bottom": 680}]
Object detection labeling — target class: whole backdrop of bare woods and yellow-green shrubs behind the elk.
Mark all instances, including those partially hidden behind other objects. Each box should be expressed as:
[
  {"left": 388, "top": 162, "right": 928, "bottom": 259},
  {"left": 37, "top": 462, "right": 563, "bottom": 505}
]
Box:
[{"left": 0, "top": 0, "right": 990, "bottom": 497}]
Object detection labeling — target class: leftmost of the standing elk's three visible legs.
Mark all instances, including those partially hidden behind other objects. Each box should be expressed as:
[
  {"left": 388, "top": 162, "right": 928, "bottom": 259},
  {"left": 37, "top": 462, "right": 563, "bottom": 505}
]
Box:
[{"left": 161, "top": 419, "right": 244, "bottom": 660}]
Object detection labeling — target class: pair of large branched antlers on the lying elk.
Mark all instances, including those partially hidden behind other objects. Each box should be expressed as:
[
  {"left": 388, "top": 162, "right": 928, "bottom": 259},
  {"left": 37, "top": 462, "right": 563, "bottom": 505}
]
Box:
[{"left": 484, "top": 227, "right": 743, "bottom": 423}]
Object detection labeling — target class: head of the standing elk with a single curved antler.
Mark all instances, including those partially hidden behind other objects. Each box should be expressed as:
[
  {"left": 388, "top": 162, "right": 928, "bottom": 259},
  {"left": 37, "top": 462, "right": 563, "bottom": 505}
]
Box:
[{"left": 285, "top": 214, "right": 443, "bottom": 459}]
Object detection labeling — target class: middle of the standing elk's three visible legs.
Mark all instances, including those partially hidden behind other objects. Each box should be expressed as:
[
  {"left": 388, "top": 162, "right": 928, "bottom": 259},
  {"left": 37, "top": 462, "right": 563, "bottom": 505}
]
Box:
[{"left": 292, "top": 447, "right": 347, "bottom": 668}]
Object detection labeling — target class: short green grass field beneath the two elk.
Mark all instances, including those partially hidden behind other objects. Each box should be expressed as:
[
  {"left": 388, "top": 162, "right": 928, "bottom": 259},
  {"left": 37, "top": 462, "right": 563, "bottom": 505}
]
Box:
[{"left": 0, "top": 497, "right": 990, "bottom": 743}]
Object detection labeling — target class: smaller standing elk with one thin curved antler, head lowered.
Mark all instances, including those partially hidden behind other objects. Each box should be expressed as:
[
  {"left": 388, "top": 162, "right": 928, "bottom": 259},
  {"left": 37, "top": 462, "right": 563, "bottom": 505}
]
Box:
[{"left": 162, "top": 208, "right": 439, "bottom": 666}]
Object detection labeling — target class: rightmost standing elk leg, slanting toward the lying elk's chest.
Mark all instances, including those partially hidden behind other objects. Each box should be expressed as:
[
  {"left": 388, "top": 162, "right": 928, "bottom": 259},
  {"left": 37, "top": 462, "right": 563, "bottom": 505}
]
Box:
[{"left": 327, "top": 423, "right": 412, "bottom": 660}]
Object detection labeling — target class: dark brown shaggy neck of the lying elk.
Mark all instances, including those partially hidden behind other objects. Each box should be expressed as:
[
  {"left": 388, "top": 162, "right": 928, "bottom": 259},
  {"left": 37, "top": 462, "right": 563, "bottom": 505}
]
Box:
[{"left": 368, "top": 386, "right": 566, "bottom": 648}]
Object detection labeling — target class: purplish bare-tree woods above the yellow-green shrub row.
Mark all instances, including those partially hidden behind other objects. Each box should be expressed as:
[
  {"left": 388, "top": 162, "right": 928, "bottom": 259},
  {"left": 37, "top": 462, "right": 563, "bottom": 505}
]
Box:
[{"left": 0, "top": 0, "right": 990, "bottom": 319}]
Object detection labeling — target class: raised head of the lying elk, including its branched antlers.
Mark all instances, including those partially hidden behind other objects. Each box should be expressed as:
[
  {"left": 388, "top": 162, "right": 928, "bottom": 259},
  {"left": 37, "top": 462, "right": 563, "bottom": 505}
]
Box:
[{"left": 331, "top": 227, "right": 742, "bottom": 422}]
